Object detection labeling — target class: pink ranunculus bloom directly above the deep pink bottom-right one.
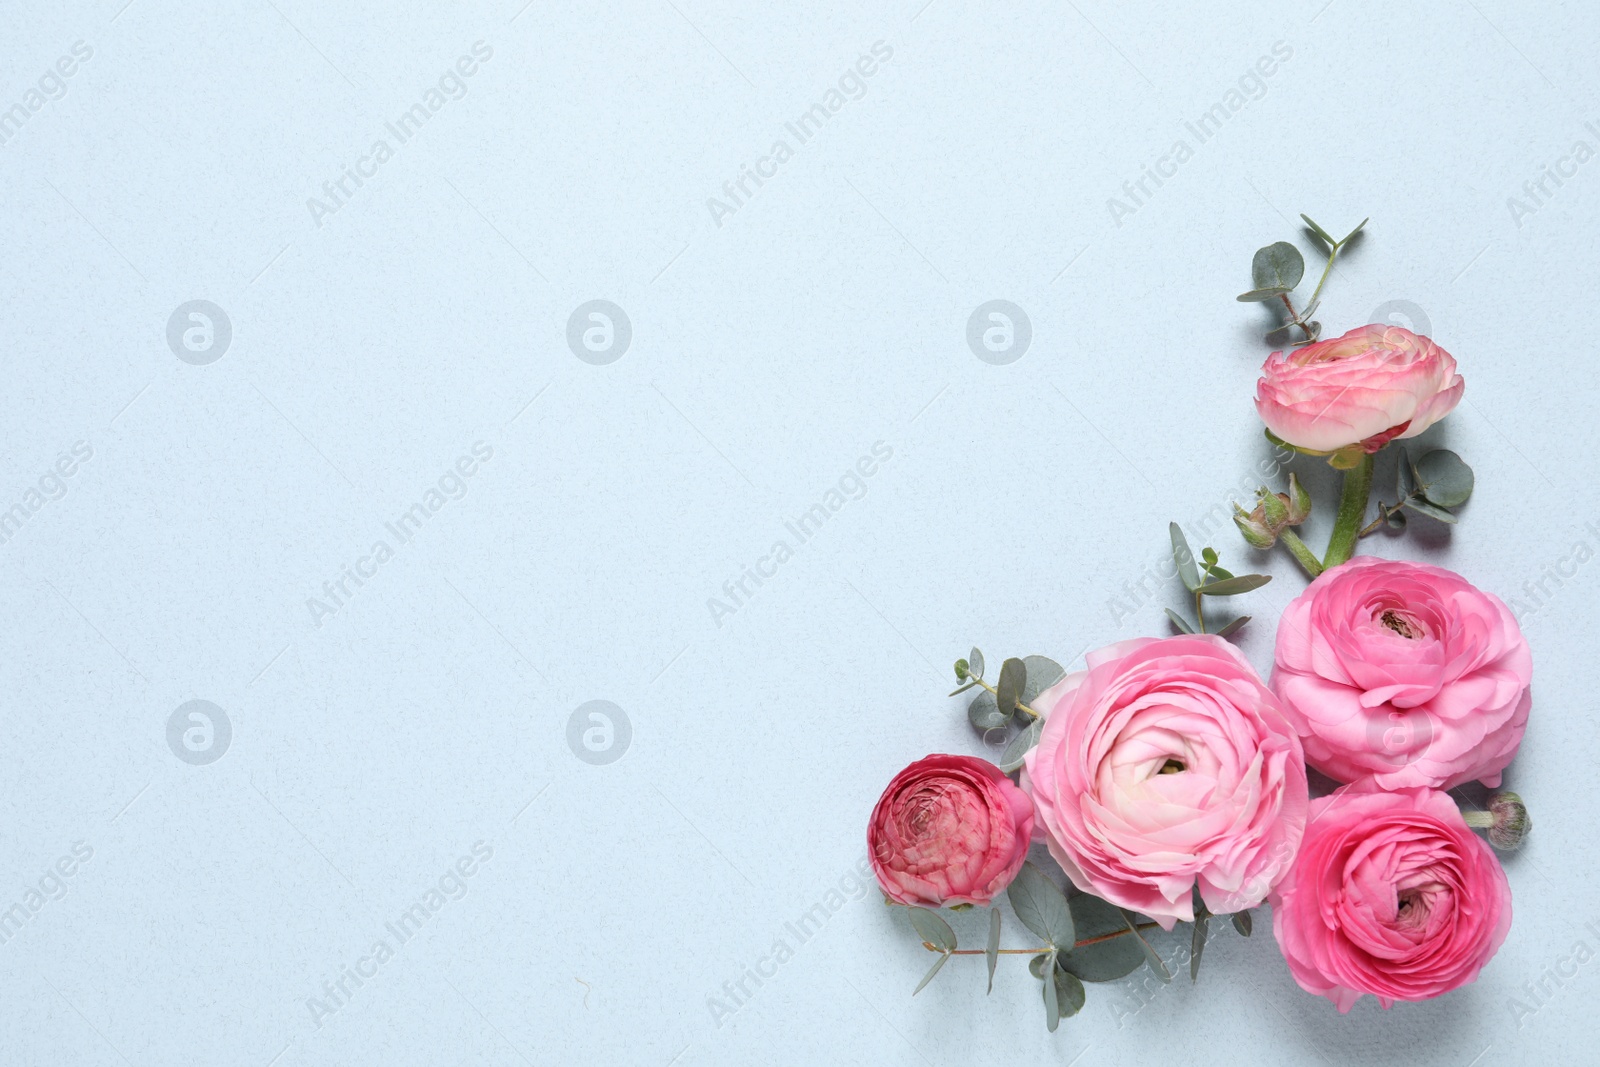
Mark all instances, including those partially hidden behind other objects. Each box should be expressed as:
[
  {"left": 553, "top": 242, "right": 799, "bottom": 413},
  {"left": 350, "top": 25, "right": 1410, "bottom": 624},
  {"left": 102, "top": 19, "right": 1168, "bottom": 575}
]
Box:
[{"left": 1272, "top": 555, "right": 1533, "bottom": 789}]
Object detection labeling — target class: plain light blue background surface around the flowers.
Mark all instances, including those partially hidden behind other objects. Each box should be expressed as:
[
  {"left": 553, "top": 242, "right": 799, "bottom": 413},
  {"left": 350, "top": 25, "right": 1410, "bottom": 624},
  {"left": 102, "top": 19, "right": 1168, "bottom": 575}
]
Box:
[{"left": 0, "top": 0, "right": 1600, "bottom": 1067}]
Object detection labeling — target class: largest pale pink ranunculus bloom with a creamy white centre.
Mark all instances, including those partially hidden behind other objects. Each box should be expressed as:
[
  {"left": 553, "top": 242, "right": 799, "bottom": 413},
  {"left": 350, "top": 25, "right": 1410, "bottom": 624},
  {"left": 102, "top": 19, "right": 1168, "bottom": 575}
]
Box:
[{"left": 1022, "top": 635, "right": 1309, "bottom": 929}]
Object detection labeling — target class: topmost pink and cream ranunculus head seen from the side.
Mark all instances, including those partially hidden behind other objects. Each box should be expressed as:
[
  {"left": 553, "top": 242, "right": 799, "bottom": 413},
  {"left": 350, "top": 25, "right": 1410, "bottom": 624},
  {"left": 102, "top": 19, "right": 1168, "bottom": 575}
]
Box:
[{"left": 1256, "top": 323, "right": 1466, "bottom": 453}]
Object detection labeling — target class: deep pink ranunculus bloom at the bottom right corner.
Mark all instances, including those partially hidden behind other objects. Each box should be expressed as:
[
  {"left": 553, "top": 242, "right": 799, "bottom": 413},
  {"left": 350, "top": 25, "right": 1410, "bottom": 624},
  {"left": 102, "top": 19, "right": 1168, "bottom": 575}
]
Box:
[{"left": 1272, "top": 784, "right": 1510, "bottom": 1011}]
